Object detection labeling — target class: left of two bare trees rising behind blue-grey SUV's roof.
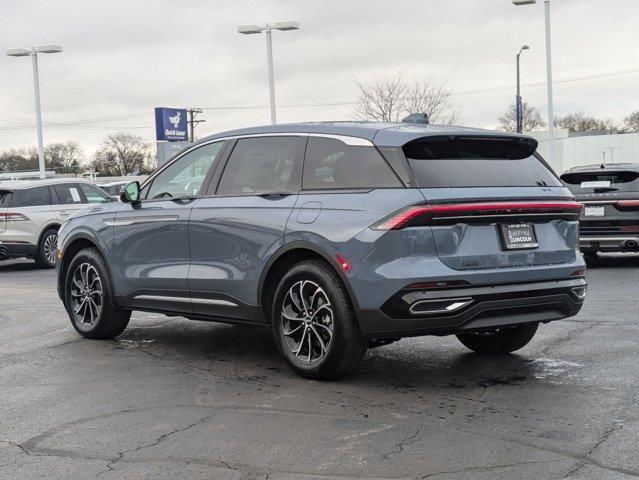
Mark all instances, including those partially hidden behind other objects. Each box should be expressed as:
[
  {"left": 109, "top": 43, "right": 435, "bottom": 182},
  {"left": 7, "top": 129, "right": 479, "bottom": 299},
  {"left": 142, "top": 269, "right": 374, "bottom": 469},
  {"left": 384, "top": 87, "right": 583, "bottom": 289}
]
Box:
[{"left": 352, "top": 75, "right": 407, "bottom": 122}]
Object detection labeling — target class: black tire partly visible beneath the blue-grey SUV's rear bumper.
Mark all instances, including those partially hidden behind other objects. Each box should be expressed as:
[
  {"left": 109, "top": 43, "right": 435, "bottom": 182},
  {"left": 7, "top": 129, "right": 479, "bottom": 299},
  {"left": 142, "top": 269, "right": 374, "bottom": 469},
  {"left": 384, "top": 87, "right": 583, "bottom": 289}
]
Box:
[{"left": 457, "top": 323, "right": 539, "bottom": 354}]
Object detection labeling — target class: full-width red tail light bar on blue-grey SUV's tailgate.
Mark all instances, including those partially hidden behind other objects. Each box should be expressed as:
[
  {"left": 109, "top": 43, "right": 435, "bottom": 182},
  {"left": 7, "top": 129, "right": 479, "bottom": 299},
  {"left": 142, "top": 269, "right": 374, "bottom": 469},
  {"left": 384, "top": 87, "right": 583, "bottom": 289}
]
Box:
[{"left": 371, "top": 201, "right": 583, "bottom": 230}]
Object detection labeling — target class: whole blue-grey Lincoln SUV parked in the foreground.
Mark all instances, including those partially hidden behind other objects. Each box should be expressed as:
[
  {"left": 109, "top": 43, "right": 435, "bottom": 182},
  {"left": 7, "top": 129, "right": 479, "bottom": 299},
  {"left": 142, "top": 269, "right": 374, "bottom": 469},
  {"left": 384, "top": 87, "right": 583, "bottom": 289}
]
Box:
[{"left": 57, "top": 122, "right": 586, "bottom": 378}]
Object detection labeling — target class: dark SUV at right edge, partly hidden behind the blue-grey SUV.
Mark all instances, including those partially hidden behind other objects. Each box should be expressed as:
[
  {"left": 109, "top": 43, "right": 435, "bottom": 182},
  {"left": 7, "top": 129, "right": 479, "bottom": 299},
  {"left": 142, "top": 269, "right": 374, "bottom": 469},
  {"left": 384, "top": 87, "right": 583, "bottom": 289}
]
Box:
[{"left": 561, "top": 163, "right": 639, "bottom": 255}]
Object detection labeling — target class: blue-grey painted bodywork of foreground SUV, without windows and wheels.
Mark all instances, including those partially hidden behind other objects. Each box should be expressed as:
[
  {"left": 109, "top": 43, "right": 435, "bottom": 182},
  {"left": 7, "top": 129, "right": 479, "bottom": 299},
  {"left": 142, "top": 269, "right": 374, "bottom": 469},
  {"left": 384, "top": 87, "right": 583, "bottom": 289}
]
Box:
[{"left": 59, "top": 122, "right": 585, "bottom": 342}]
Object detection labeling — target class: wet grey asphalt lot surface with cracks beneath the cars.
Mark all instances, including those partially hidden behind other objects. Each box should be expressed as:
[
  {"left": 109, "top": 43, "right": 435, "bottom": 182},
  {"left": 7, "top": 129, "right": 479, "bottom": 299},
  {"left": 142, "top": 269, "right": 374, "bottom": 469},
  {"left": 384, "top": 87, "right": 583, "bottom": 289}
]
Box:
[{"left": 0, "top": 255, "right": 639, "bottom": 480}]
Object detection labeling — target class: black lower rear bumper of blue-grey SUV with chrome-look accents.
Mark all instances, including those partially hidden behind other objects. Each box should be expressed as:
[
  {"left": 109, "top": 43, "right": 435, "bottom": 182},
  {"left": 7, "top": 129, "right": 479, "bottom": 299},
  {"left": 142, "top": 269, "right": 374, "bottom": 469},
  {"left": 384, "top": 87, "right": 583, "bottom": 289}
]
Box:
[{"left": 357, "top": 278, "right": 587, "bottom": 339}]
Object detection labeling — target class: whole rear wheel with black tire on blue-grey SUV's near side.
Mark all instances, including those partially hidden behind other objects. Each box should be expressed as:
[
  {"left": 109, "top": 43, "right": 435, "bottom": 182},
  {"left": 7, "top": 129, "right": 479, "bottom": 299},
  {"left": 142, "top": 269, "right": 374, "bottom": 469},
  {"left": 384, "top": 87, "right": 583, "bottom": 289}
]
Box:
[{"left": 271, "top": 260, "right": 368, "bottom": 380}]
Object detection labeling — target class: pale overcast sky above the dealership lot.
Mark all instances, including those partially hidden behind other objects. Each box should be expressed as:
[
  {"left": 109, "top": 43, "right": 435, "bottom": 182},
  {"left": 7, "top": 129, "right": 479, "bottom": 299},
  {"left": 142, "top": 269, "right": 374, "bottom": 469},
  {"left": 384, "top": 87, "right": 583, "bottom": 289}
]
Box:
[{"left": 0, "top": 0, "right": 639, "bottom": 153}]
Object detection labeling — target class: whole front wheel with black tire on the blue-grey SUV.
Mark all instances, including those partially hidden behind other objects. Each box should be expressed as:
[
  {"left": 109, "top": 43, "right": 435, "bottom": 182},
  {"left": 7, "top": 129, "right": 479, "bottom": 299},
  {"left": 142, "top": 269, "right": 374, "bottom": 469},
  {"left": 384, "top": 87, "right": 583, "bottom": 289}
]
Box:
[{"left": 64, "top": 248, "right": 131, "bottom": 339}]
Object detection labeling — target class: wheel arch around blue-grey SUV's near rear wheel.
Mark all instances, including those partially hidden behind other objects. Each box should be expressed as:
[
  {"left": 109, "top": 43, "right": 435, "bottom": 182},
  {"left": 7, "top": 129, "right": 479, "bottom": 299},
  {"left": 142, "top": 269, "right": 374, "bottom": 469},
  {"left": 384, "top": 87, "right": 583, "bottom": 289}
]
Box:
[{"left": 257, "top": 241, "right": 358, "bottom": 320}]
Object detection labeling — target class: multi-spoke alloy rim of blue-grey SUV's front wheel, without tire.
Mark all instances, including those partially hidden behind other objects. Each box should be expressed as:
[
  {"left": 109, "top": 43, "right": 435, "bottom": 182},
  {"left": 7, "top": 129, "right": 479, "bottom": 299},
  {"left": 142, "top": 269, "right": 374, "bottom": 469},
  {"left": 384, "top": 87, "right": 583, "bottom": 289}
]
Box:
[{"left": 71, "top": 263, "right": 104, "bottom": 326}]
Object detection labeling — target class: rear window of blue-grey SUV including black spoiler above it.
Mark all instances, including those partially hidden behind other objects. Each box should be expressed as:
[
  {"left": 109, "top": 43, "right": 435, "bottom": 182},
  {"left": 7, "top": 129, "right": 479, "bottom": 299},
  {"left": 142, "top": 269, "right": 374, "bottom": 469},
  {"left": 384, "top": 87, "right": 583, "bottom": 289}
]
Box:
[{"left": 404, "top": 139, "right": 562, "bottom": 188}]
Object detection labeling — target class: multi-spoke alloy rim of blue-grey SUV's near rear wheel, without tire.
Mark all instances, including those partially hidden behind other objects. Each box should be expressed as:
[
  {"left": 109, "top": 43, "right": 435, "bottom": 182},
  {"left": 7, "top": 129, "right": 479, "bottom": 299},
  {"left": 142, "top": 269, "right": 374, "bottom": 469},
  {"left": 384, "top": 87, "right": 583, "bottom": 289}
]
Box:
[{"left": 281, "top": 280, "right": 334, "bottom": 363}]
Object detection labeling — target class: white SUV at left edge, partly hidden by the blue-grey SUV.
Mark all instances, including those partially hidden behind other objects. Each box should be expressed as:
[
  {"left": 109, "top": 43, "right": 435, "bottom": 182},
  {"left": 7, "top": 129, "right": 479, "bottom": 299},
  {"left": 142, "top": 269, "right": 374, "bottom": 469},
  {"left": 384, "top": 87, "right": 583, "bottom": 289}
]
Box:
[{"left": 0, "top": 178, "right": 111, "bottom": 268}]
